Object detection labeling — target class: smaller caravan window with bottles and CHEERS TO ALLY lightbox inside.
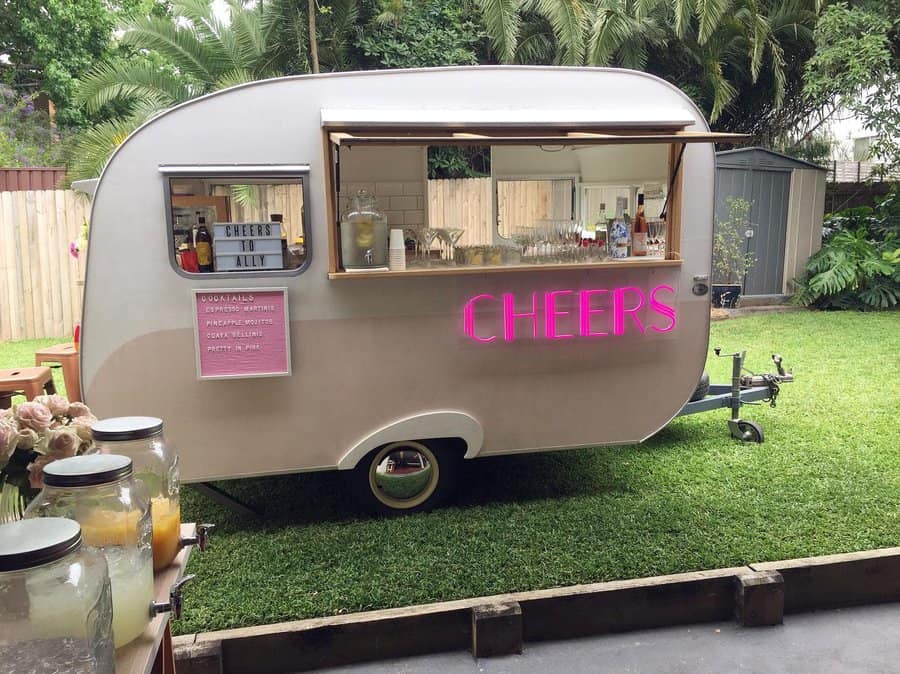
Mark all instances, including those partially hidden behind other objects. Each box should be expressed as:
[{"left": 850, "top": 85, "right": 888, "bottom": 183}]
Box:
[{"left": 160, "top": 165, "right": 310, "bottom": 276}]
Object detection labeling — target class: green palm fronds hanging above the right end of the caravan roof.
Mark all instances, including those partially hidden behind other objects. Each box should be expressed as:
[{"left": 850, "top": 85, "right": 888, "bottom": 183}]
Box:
[{"left": 476, "top": 0, "right": 823, "bottom": 121}]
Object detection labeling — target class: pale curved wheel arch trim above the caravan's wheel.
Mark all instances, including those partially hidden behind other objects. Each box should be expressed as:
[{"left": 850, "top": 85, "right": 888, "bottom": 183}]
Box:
[{"left": 337, "top": 410, "right": 484, "bottom": 470}]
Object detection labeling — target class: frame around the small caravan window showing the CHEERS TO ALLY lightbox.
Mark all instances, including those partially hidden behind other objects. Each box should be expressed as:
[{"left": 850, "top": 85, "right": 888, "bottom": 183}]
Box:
[{"left": 158, "top": 164, "right": 313, "bottom": 281}]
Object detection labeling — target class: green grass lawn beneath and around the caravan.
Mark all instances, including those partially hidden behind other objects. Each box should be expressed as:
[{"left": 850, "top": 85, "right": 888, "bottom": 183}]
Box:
[{"left": 0, "top": 312, "right": 900, "bottom": 633}]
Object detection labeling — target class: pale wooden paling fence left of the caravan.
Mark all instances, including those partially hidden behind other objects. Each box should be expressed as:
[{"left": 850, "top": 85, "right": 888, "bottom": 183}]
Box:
[{"left": 0, "top": 190, "right": 90, "bottom": 338}]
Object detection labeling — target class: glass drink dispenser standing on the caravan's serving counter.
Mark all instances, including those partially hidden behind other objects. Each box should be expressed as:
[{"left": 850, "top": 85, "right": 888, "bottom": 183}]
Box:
[{"left": 341, "top": 190, "right": 388, "bottom": 271}]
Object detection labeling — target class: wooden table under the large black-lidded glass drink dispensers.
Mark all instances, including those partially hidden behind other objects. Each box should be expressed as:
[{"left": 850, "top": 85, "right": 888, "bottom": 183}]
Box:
[{"left": 116, "top": 524, "right": 197, "bottom": 674}]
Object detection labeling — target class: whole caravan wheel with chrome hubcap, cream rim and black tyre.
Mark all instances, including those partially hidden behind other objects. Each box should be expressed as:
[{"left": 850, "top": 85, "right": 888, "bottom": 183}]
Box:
[{"left": 352, "top": 440, "right": 462, "bottom": 515}]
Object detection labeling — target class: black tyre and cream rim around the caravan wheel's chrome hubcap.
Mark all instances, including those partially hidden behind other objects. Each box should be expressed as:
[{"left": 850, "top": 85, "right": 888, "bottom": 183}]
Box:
[{"left": 350, "top": 439, "right": 464, "bottom": 515}]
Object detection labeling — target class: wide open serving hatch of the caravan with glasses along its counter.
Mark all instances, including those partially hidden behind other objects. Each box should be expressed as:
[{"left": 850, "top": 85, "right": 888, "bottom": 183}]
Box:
[{"left": 325, "top": 126, "right": 734, "bottom": 278}]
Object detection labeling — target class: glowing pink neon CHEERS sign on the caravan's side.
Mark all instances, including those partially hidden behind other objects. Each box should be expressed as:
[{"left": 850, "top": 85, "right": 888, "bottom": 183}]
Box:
[{"left": 463, "top": 285, "right": 677, "bottom": 344}]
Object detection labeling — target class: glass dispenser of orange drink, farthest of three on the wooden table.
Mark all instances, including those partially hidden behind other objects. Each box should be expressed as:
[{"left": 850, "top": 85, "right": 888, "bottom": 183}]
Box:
[{"left": 91, "top": 417, "right": 181, "bottom": 571}]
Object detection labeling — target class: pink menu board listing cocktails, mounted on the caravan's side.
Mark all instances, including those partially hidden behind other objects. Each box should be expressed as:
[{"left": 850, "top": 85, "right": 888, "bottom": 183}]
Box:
[{"left": 194, "top": 288, "right": 291, "bottom": 379}]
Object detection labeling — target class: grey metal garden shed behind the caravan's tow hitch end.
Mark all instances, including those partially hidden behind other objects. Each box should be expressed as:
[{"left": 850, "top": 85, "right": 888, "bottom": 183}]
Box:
[{"left": 716, "top": 147, "right": 826, "bottom": 296}]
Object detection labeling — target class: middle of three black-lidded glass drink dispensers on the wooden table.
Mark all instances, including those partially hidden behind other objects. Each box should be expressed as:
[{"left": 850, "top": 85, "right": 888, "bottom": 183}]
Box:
[{"left": 25, "top": 454, "right": 153, "bottom": 648}]
